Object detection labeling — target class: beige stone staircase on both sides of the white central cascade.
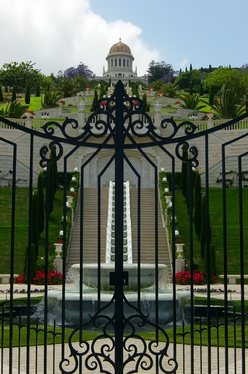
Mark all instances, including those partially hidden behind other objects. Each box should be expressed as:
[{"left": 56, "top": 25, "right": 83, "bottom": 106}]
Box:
[{"left": 67, "top": 187, "right": 171, "bottom": 275}]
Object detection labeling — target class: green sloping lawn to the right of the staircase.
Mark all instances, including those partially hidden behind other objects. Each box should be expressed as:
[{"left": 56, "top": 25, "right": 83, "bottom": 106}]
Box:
[{"left": 176, "top": 188, "right": 248, "bottom": 274}]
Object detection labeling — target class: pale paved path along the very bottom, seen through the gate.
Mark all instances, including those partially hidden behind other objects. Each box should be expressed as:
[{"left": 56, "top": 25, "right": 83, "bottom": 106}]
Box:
[{"left": 0, "top": 340, "right": 248, "bottom": 374}]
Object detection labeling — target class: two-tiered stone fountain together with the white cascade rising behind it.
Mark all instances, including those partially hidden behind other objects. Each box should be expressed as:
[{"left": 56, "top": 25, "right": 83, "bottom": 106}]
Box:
[{"left": 44, "top": 181, "right": 188, "bottom": 326}]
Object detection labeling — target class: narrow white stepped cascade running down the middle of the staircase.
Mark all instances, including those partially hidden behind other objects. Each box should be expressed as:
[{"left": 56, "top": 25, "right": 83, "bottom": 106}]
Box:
[{"left": 106, "top": 181, "right": 133, "bottom": 263}]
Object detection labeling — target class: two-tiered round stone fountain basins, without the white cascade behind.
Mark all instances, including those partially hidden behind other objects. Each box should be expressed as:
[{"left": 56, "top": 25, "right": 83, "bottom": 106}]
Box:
[{"left": 48, "top": 263, "right": 188, "bottom": 326}]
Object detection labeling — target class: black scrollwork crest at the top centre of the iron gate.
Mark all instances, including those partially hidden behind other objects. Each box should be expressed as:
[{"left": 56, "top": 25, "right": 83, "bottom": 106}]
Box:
[{"left": 37, "top": 81, "right": 197, "bottom": 148}]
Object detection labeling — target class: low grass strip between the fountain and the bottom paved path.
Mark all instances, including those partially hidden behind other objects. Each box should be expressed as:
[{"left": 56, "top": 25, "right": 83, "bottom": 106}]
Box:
[{"left": 0, "top": 323, "right": 248, "bottom": 348}]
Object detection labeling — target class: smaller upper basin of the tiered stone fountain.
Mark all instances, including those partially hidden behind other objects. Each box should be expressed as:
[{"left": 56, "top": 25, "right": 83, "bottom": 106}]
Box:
[{"left": 71, "top": 263, "right": 167, "bottom": 291}]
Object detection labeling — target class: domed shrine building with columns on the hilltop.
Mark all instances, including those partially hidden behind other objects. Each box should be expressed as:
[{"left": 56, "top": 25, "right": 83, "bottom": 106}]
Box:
[{"left": 102, "top": 39, "right": 147, "bottom": 83}]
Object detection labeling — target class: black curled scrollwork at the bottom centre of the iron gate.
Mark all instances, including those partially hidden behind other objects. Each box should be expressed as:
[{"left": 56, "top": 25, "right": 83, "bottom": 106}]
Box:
[{"left": 59, "top": 294, "right": 178, "bottom": 374}]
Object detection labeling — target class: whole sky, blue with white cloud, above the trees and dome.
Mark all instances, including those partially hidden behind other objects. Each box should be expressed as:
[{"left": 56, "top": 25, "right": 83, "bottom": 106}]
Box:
[{"left": 0, "top": 0, "right": 248, "bottom": 76}]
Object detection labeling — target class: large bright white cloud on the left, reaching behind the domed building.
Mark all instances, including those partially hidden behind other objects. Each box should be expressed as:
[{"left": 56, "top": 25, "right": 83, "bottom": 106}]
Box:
[{"left": 0, "top": 0, "right": 159, "bottom": 75}]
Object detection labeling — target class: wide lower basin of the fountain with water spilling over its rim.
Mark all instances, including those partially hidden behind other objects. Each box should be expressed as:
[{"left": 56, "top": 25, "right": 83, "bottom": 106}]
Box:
[{"left": 48, "top": 288, "right": 189, "bottom": 328}]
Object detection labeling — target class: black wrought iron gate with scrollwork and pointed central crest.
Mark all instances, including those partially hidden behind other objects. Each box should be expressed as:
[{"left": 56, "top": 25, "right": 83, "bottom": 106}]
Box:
[{"left": 0, "top": 81, "right": 248, "bottom": 374}]
